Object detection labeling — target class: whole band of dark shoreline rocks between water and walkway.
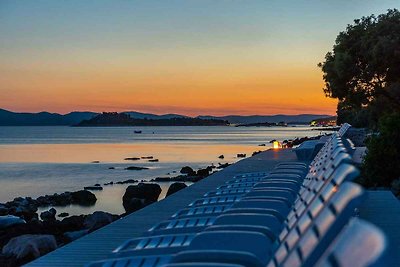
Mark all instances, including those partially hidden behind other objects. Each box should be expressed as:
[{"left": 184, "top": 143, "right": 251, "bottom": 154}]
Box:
[{"left": 0, "top": 159, "right": 230, "bottom": 266}]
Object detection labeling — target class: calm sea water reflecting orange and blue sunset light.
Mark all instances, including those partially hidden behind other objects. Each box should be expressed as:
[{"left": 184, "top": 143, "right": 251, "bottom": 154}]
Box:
[{"left": 0, "top": 126, "right": 319, "bottom": 214}]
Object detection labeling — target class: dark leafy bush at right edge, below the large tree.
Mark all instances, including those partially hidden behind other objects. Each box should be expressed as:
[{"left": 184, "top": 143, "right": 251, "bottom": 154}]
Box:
[{"left": 361, "top": 114, "right": 400, "bottom": 187}]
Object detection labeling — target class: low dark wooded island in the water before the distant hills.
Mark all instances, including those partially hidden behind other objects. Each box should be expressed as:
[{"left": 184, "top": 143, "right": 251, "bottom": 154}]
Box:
[{"left": 74, "top": 112, "right": 229, "bottom": 127}]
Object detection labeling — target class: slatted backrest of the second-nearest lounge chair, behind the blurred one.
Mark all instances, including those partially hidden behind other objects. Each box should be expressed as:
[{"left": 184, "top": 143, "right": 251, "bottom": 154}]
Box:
[{"left": 275, "top": 182, "right": 364, "bottom": 266}]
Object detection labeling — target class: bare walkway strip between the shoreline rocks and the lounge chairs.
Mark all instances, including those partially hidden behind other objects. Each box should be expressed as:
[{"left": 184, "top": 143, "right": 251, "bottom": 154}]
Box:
[{"left": 27, "top": 149, "right": 304, "bottom": 267}]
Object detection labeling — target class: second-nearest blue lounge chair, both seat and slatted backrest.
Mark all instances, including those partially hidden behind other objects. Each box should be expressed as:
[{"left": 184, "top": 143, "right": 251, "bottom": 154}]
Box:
[{"left": 163, "top": 182, "right": 363, "bottom": 266}]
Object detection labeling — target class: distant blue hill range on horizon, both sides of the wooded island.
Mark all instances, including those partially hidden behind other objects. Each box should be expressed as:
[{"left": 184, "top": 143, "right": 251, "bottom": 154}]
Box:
[{"left": 0, "top": 109, "right": 330, "bottom": 126}]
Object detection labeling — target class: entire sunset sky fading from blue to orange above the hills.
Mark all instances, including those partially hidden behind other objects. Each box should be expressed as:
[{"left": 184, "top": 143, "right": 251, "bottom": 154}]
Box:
[{"left": 0, "top": 0, "right": 400, "bottom": 115}]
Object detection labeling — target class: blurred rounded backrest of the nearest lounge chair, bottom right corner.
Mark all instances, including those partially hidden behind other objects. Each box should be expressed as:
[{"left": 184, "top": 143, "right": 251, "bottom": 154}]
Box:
[{"left": 316, "top": 219, "right": 390, "bottom": 267}]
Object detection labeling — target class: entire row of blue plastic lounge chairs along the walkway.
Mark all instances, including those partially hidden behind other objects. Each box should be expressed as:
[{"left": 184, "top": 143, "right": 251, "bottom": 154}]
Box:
[{"left": 88, "top": 124, "right": 389, "bottom": 267}]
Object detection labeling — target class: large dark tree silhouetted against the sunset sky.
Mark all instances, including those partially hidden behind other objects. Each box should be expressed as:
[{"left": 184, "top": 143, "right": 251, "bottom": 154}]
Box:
[{"left": 318, "top": 9, "right": 400, "bottom": 127}]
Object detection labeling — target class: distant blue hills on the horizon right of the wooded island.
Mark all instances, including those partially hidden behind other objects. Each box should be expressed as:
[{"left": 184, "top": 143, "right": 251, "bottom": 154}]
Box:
[{"left": 198, "top": 114, "right": 329, "bottom": 124}]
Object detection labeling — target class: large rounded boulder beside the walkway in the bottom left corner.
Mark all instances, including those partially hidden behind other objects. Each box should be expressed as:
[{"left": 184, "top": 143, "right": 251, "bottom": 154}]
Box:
[{"left": 2, "top": 235, "right": 57, "bottom": 260}]
